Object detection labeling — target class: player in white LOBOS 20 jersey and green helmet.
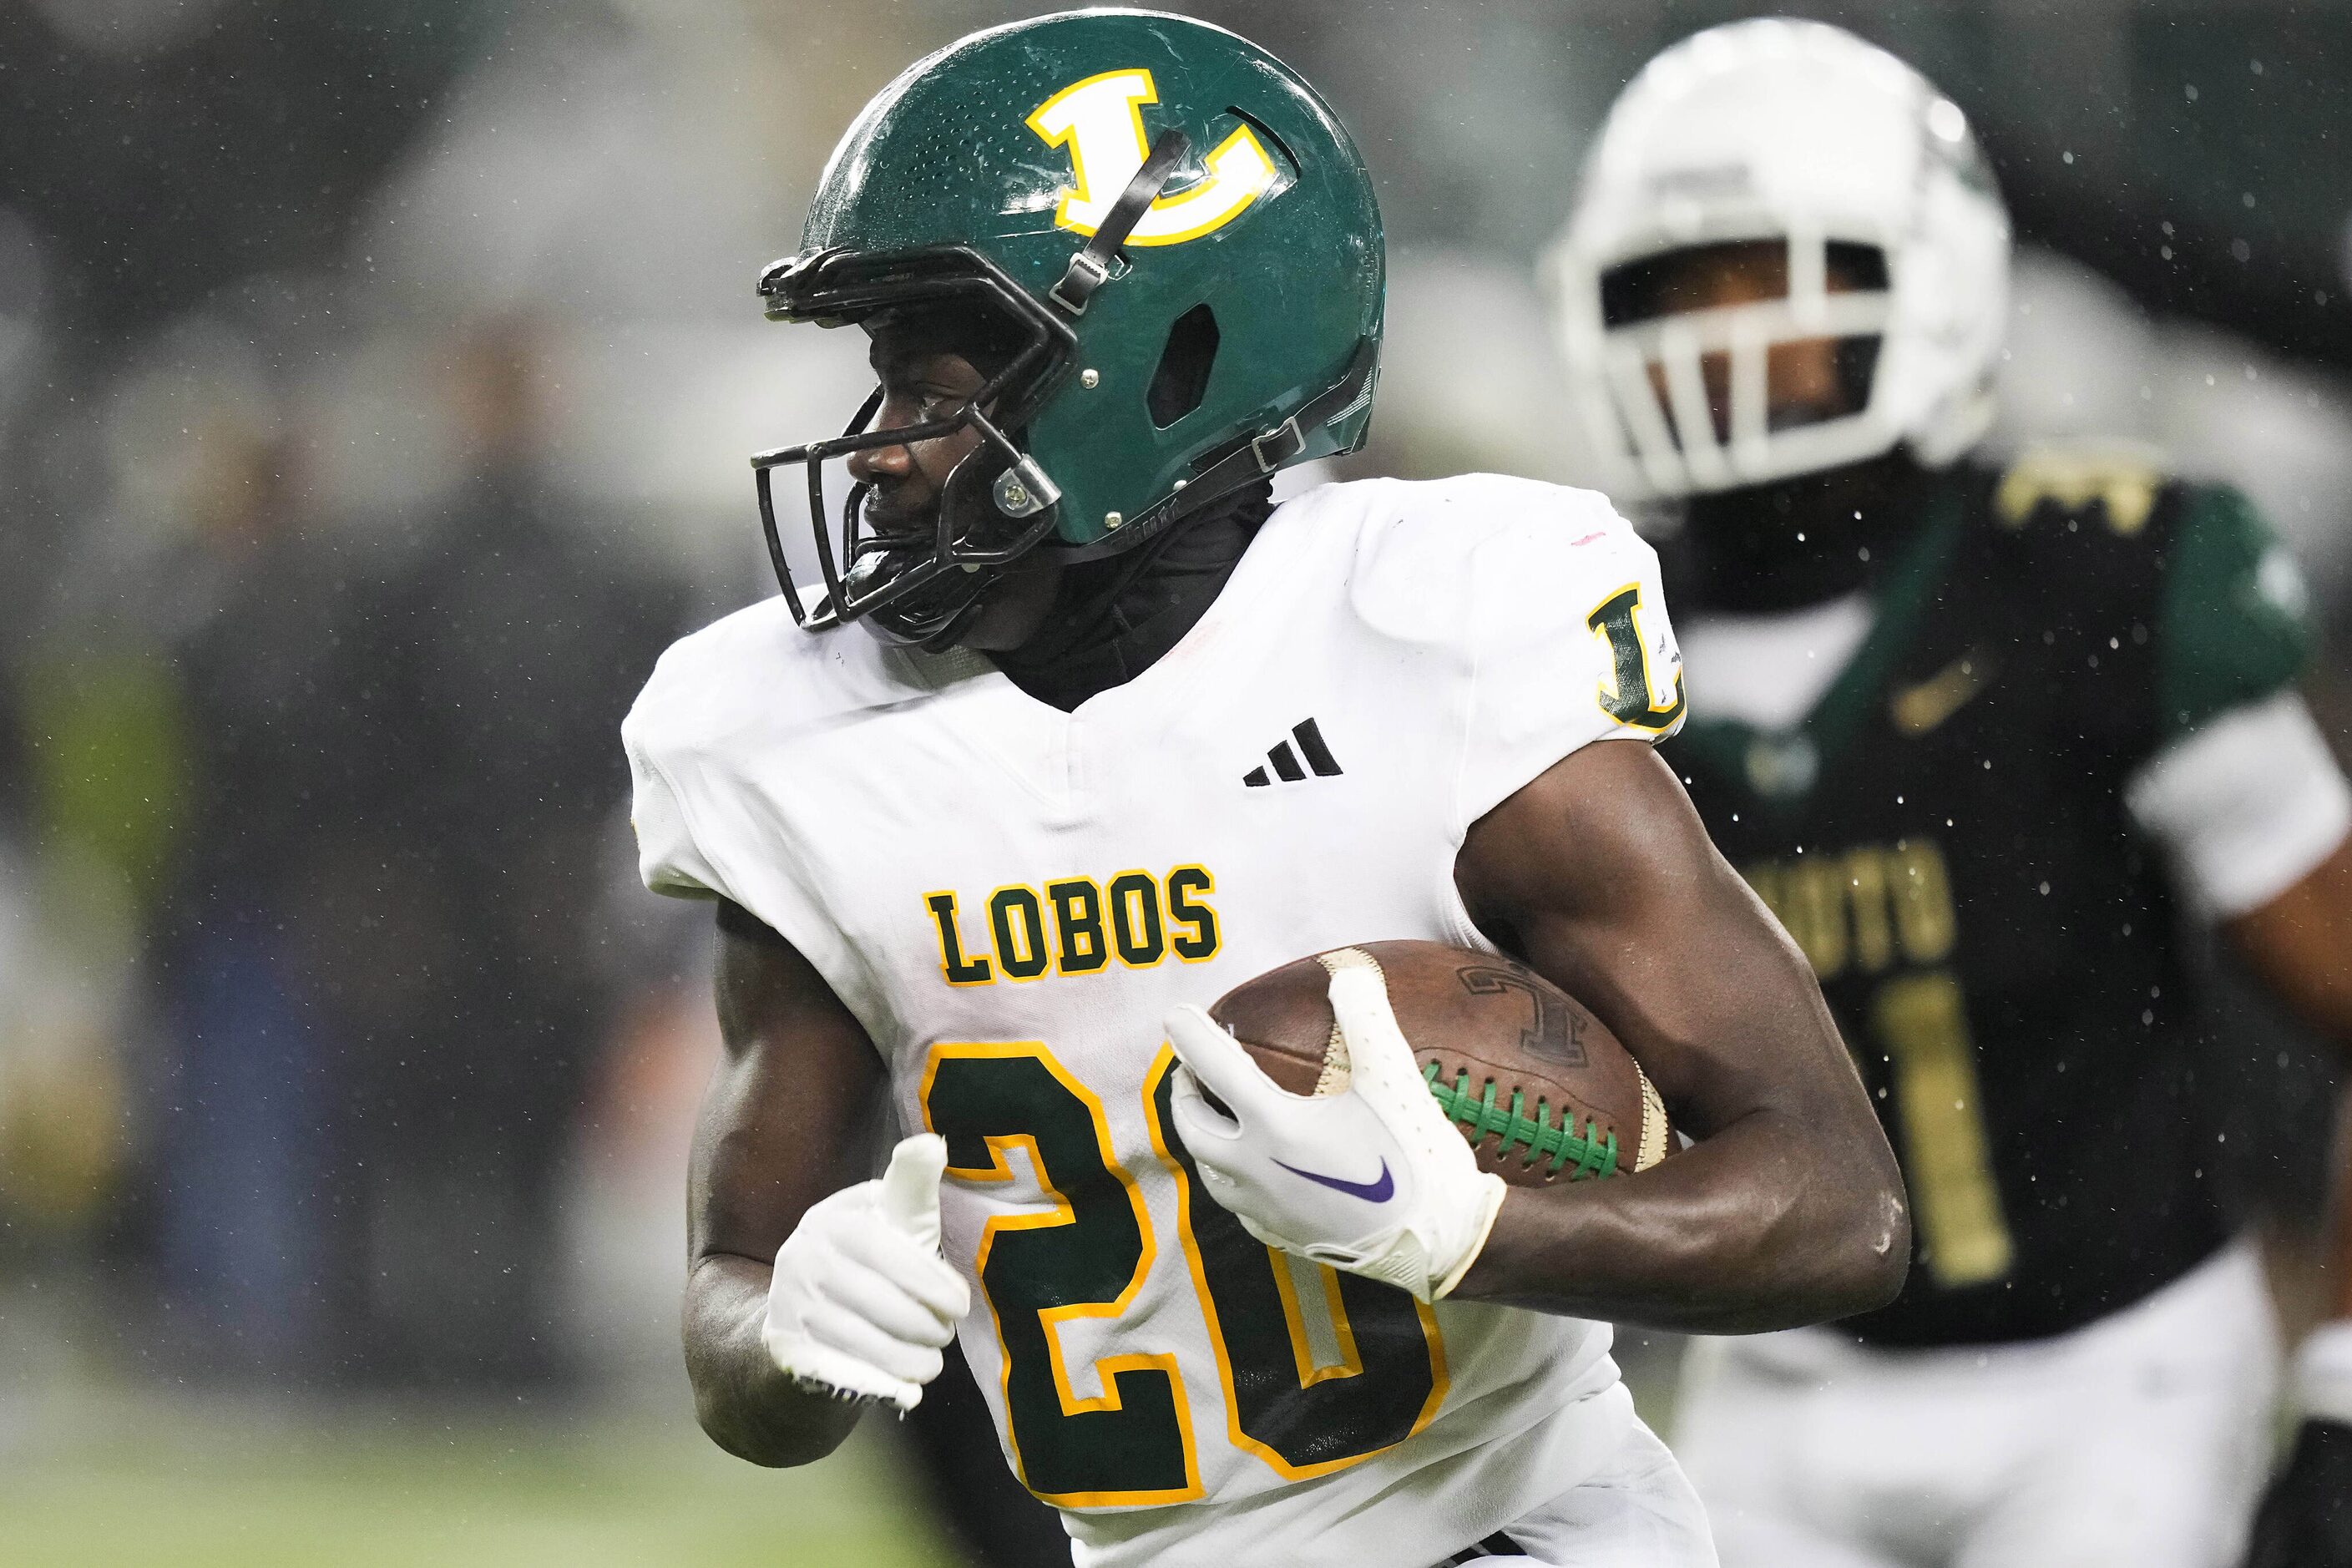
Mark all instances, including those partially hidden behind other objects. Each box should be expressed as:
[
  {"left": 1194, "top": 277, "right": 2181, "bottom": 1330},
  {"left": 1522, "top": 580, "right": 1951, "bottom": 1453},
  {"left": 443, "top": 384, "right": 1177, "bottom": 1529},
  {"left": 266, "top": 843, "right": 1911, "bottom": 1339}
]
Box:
[{"left": 624, "top": 12, "right": 1909, "bottom": 1568}]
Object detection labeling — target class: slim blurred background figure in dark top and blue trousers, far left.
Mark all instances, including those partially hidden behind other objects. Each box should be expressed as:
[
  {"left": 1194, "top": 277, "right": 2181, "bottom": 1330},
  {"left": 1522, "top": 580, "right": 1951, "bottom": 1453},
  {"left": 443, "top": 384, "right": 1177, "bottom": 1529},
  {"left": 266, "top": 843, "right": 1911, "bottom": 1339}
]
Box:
[{"left": 148, "top": 414, "right": 357, "bottom": 1375}]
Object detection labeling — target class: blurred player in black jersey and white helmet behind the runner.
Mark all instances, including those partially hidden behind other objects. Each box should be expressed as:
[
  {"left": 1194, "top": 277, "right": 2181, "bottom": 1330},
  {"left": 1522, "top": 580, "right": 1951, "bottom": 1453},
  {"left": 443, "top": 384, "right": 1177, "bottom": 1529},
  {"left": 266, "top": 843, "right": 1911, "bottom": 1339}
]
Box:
[{"left": 1552, "top": 21, "right": 2352, "bottom": 1568}]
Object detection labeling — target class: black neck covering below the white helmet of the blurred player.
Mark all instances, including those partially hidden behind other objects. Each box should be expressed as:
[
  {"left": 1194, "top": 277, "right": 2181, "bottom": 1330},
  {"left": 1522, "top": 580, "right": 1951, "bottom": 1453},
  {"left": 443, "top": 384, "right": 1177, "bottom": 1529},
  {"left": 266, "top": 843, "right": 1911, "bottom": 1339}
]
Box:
[{"left": 1672, "top": 449, "right": 1929, "bottom": 614}]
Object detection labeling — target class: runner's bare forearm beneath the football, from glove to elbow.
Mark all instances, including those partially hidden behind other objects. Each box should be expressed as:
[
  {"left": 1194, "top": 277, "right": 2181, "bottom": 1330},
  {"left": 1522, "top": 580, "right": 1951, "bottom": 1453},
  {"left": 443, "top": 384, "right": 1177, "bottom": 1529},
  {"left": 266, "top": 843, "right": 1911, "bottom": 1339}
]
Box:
[{"left": 1456, "top": 1112, "right": 1909, "bottom": 1333}]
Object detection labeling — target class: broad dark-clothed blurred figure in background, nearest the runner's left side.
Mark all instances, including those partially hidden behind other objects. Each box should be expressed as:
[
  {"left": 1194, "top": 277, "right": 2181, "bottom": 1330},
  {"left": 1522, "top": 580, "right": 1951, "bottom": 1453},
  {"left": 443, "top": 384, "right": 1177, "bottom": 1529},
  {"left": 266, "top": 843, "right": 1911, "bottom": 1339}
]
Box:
[{"left": 320, "top": 317, "right": 682, "bottom": 1392}]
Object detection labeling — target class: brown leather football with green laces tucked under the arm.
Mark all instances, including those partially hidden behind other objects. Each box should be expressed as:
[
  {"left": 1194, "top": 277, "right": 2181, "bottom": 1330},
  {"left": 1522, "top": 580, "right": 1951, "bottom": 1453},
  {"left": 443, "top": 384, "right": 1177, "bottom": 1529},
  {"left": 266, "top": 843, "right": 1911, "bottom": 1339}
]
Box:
[{"left": 1209, "top": 943, "right": 1675, "bottom": 1187}]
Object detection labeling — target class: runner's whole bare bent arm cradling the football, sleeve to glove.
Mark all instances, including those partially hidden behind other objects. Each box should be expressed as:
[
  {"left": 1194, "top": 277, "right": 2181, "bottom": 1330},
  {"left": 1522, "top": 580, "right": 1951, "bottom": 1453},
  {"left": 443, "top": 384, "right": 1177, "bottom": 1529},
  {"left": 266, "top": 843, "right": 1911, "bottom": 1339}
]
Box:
[{"left": 1456, "top": 743, "right": 1909, "bottom": 1333}]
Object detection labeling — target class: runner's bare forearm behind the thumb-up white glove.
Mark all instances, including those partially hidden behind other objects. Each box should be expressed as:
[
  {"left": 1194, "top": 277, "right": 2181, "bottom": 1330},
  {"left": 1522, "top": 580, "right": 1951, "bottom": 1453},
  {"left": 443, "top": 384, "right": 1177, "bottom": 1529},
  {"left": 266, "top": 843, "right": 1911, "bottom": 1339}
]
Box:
[{"left": 685, "top": 1256, "right": 861, "bottom": 1467}]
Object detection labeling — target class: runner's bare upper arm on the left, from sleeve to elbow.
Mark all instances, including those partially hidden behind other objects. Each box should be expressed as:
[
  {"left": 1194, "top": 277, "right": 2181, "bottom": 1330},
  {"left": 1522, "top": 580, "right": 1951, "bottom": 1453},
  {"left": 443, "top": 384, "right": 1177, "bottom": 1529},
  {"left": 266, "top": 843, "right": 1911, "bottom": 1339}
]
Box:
[{"left": 687, "top": 910, "right": 884, "bottom": 1262}]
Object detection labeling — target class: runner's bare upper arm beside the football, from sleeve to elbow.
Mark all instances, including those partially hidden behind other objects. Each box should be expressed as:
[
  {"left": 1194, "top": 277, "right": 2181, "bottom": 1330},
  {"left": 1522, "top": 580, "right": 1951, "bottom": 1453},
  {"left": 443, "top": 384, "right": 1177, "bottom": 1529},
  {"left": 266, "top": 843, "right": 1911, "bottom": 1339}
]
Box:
[{"left": 1459, "top": 741, "right": 1868, "bottom": 1138}]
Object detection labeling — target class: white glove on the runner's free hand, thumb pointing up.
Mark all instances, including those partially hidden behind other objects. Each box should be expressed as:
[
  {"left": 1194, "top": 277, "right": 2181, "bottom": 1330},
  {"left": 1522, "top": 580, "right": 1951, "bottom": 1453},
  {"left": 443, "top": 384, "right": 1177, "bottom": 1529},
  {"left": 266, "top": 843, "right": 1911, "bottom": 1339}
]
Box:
[{"left": 760, "top": 1133, "right": 971, "bottom": 1410}]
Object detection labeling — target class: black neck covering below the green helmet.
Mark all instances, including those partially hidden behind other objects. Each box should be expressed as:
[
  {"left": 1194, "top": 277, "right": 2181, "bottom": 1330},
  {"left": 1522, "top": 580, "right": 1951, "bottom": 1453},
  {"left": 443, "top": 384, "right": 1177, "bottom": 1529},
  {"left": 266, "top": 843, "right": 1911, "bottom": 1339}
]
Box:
[{"left": 990, "top": 484, "right": 1275, "bottom": 712}]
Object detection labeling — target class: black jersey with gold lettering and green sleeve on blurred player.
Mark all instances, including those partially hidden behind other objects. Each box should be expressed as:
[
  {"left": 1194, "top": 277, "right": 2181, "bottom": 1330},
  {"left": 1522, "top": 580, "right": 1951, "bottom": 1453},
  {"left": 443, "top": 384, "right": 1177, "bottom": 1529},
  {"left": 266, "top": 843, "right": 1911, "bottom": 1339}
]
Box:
[{"left": 1665, "top": 453, "right": 2307, "bottom": 1345}]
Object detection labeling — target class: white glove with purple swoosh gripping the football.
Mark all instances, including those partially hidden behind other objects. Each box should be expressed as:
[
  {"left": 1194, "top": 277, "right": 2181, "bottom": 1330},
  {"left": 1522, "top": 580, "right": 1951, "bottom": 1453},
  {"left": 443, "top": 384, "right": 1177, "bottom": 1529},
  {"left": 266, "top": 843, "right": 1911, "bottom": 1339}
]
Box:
[{"left": 1166, "top": 948, "right": 1505, "bottom": 1302}]
